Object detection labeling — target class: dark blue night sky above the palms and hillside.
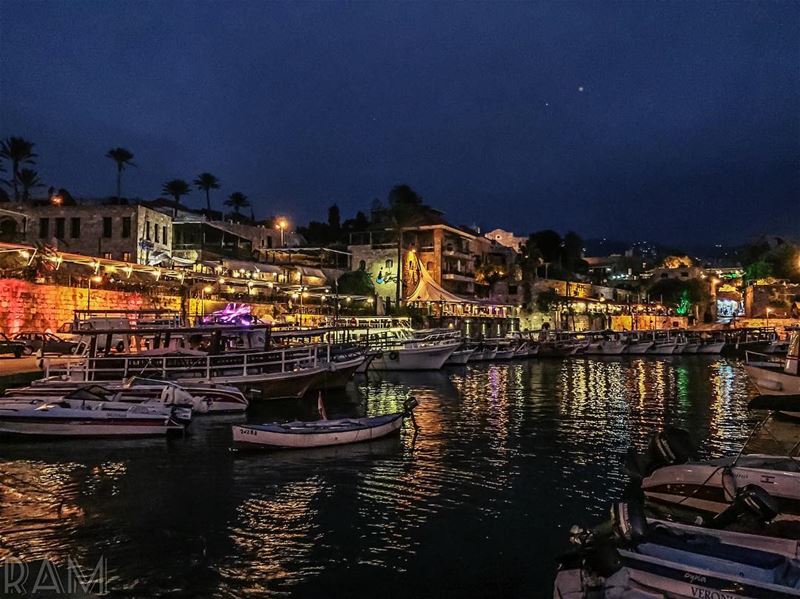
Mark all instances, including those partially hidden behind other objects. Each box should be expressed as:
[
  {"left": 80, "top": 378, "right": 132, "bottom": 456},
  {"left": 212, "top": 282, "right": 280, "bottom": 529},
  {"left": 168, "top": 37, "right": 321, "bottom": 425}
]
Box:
[{"left": 0, "top": 0, "right": 800, "bottom": 244}]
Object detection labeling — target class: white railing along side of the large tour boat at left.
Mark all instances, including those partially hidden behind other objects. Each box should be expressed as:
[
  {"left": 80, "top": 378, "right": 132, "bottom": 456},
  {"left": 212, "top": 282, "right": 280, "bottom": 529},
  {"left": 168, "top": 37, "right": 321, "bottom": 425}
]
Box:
[{"left": 44, "top": 347, "right": 322, "bottom": 380}]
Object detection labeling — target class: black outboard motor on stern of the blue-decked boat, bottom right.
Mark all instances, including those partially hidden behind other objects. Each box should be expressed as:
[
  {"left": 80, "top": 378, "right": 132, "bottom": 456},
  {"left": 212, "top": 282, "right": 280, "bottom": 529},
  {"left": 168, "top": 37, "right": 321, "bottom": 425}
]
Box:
[{"left": 570, "top": 501, "right": 647, "bottom": 578}]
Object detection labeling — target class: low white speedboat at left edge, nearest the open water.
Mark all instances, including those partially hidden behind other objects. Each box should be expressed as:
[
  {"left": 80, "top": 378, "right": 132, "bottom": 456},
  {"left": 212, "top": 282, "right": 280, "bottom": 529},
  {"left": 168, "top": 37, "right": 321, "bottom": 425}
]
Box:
[{"left": 0, "top": 401, "right": 191, "bottom": 438}]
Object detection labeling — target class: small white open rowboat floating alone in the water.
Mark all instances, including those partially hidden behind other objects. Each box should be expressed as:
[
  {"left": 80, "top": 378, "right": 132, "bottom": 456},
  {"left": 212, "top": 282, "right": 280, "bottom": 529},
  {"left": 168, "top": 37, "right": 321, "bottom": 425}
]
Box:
[{"left": 232, "top": 397, "right": 417, "bottom": 449}]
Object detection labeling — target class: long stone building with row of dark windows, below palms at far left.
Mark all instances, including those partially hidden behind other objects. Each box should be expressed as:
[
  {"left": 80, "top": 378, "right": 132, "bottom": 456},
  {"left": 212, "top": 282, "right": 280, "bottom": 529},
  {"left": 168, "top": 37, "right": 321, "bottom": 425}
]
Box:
[{"left": 0, "top": 202, "right": 172, "bottom": 264}]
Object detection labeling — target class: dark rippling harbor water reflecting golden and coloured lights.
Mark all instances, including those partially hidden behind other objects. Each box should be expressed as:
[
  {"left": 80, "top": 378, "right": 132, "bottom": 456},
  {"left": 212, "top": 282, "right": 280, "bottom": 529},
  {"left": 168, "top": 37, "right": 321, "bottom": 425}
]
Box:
[{"left": 0, "top": 356, "right": 754, "bottom": 599}]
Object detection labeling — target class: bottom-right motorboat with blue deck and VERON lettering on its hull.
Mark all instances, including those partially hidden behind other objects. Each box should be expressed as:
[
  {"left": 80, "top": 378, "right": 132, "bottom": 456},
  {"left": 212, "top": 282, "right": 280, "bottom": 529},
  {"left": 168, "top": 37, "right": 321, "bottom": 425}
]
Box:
[{"left": 554, "top": 502, "right": 800, "bottom": 599}]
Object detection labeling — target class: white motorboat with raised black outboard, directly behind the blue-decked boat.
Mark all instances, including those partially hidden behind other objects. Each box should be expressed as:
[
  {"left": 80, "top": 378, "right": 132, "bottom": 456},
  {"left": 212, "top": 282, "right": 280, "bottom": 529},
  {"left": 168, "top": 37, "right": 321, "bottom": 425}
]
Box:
[{"left": 627, "top": 395, "right": 800, "bottom": 521}]
